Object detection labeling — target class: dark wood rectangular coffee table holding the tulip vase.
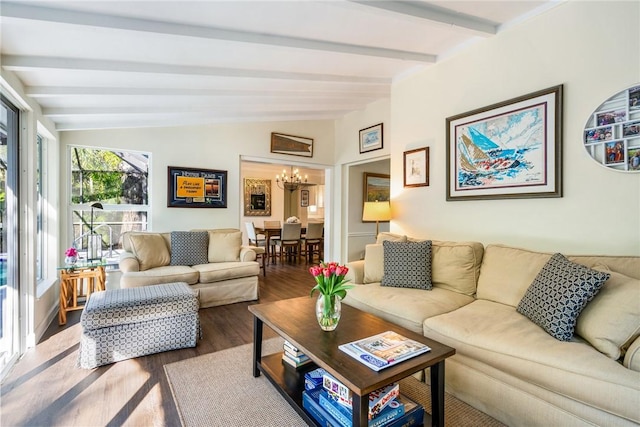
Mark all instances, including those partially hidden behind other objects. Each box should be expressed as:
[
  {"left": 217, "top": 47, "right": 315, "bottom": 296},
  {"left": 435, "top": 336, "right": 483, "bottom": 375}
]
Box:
[{"left": 249, "top": 297, "right": 456, "bottom": 426}]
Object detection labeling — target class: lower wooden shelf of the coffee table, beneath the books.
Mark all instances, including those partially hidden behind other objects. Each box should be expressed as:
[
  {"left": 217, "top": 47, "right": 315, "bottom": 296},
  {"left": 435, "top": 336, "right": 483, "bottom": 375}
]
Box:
[{"left": 258, "top": 352, "right": 424, "bottom": 426}]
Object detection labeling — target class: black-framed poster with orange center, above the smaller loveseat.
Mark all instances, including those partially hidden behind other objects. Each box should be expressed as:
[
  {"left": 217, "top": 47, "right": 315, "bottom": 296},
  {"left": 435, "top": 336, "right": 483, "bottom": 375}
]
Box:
[{"left": 167, "top": 166, "right": 227, "bottom": 208}]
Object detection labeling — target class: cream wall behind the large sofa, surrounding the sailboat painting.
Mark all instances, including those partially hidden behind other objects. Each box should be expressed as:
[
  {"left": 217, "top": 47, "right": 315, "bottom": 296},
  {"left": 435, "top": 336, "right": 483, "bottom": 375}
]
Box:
[{"left": 390, "top": 1, "right": 640, "bottom": 255}]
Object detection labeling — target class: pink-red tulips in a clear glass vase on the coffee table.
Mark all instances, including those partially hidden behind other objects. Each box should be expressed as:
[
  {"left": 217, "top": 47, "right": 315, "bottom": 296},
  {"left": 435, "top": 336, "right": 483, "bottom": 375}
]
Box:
[{"left": 309, "top": 262, "right": 353, "bottom": 331}]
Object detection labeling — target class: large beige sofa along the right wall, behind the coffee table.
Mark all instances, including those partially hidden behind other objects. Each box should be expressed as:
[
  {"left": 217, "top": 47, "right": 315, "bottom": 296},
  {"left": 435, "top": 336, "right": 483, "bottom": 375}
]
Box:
[{"left": 344, "top": 233, "right": 640, "bottom": 426}]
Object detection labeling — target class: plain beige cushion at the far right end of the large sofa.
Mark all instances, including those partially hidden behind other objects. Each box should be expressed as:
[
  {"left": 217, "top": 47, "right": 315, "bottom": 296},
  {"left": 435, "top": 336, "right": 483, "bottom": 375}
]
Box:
[{"left": 576, "top": 267, "right": 640, "bottom": 360}]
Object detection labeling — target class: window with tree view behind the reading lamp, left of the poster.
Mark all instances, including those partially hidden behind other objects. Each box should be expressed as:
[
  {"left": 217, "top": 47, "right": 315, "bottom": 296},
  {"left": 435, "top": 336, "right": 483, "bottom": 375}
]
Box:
[{"left": 69, "top": 147, "right": 150, "bottom": 259}]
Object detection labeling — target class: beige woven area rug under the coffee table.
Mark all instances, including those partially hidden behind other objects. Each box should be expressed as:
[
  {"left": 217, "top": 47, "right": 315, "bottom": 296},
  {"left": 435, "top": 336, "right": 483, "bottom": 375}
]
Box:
[{"left": 164, "top": 338, "right": 503, "bottom": 427}]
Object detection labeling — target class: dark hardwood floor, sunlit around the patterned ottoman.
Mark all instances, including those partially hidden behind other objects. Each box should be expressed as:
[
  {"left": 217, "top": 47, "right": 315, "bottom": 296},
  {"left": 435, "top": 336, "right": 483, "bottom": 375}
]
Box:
[{"left": 0, "top": 262, "right": 314, "bottom": 426}]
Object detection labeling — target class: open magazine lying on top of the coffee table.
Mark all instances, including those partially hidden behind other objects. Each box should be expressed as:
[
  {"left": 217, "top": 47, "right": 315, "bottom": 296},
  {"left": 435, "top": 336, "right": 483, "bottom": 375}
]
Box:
[{"left": 338, "top": 331, "right": 431, "bottom": 371}]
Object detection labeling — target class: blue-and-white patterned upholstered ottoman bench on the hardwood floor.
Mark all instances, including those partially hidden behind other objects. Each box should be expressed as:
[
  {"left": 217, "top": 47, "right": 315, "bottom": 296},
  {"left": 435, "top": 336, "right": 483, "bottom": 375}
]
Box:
[{"left": 78, "top": 282, "right": 200, "bottom": 369}]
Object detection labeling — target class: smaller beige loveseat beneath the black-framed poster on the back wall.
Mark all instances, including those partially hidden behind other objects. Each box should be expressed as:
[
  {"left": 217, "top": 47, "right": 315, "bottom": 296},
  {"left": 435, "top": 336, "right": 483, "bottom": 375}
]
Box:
[{"left": 120, "top": 228, "right": 260, "bottom": 308}]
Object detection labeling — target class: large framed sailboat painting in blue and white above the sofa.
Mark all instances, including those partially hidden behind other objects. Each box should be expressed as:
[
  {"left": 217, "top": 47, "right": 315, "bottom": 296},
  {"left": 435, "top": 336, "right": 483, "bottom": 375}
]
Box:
[{"left": 446, "top": 85, "right": 562, "bottom": 201}]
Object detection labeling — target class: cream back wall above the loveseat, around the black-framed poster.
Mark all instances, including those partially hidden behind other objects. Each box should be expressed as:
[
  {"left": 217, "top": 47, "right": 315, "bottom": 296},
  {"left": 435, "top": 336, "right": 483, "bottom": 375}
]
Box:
[{"left": 60, "top": 121, "right": 334, "bottom": 239}]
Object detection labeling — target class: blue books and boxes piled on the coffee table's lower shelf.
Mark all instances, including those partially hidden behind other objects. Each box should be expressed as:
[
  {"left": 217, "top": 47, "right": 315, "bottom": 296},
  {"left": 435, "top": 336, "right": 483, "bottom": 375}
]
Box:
[{"left": 302, "top": 368, "right": 424, "bottom": 427}]
